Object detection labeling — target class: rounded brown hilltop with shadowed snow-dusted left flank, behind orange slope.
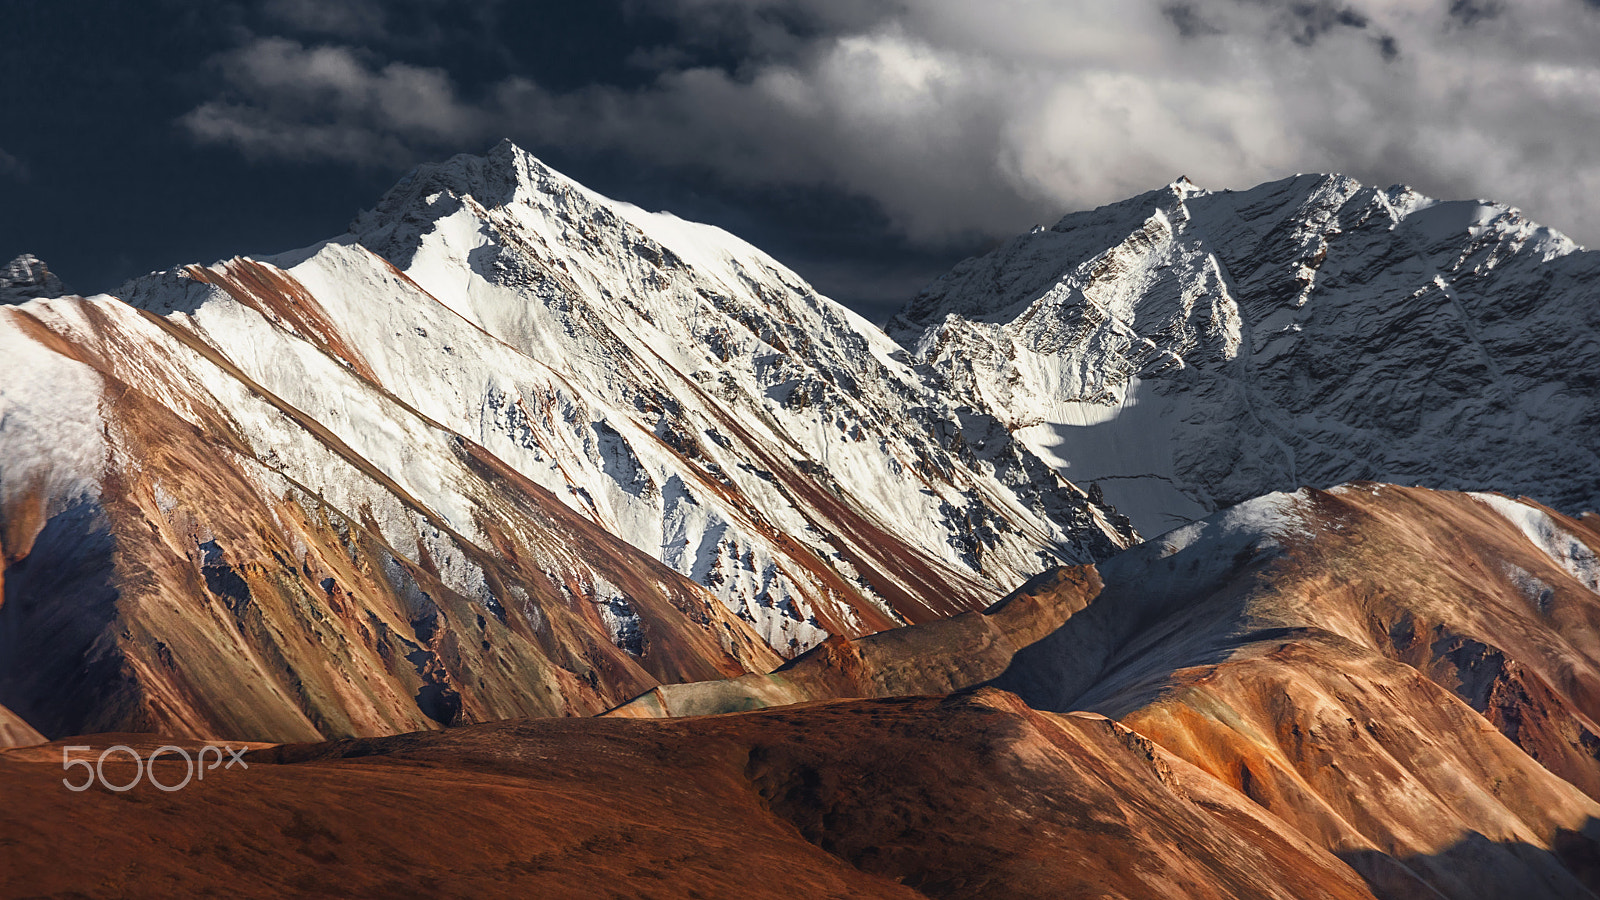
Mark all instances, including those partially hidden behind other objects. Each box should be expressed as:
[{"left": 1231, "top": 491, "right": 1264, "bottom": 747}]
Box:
[{"left": 1043, "top": 484, "right": 1600, "bottom": 796}]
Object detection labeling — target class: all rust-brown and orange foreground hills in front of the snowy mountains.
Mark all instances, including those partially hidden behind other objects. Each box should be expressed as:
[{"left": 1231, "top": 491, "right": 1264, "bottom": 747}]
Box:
[{"left": 12, "top": 484, "right": 1600, "bottom": 900}]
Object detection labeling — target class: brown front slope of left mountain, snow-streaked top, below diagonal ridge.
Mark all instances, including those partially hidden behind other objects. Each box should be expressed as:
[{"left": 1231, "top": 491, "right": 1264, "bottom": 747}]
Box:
[{"left": 0, "top": 298, "right": 778, "bottom": 740}]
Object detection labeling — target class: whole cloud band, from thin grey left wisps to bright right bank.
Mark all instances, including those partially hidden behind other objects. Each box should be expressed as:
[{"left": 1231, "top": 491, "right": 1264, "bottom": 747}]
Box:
[{"left": 187, "top": 0, "right": 1600, "bottom": 243}]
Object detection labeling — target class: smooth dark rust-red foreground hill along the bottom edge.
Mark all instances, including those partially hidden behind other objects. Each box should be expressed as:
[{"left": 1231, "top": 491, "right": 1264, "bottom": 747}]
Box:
[{"left": 0, "top": 692, "right": 1371, "bottom": 900}]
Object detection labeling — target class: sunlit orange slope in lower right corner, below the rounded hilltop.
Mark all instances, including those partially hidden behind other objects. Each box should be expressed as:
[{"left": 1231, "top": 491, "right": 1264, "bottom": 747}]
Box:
[{"left": 1123, "top": 637, "right": 1600, "bottom": 898}]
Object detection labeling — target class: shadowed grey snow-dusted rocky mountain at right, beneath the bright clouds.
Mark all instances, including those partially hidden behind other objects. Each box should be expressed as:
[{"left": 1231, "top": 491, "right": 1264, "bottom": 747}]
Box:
[{"left": 890, "top": 175, "right": 1600, "bottom": 536}]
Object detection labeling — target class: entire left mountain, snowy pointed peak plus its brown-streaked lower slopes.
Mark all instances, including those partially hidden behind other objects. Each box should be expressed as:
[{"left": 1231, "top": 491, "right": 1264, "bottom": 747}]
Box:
[{"left": 0, "top": 143, "right": 1133, "bottom": 740}]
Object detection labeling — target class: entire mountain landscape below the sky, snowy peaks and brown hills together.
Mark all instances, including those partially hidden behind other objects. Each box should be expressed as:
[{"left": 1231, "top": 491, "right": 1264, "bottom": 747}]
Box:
[{"left": 0, "top": 143, "right": 1600, "bottom": 900}]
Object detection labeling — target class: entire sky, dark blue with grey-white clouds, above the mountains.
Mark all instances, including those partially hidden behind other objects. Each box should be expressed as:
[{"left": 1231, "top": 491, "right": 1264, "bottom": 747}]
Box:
[{"left": 12, "top": 0, "right": 1600, "bottom": 315}]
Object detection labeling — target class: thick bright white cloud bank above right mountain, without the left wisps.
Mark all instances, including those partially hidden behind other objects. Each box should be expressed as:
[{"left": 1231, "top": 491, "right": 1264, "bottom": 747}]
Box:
[{"left": 582, "top": 0, "right": 1600, "bottom": 239}]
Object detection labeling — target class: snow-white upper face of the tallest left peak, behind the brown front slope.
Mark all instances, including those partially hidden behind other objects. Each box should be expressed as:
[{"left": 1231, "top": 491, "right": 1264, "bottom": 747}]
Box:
[{"left": 334, "top": 143, "right": 1131, "bottom": 637}]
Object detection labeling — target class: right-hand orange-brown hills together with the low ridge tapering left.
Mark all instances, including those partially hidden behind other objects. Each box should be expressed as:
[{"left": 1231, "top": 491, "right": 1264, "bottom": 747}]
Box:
[{"left": 610, "top": 484, "right": 1600, "bottom": 898}]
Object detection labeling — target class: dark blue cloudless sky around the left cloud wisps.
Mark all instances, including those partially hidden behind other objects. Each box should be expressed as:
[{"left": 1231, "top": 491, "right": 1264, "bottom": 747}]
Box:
[{"left": 0, "top": 0, "right": 978, "bottom": 315}]
